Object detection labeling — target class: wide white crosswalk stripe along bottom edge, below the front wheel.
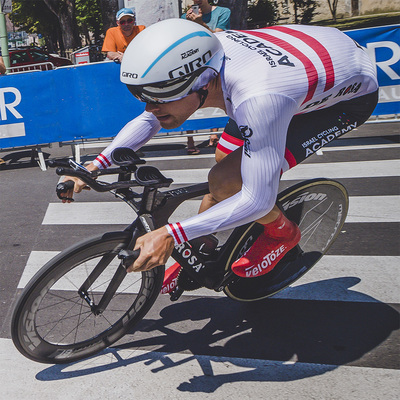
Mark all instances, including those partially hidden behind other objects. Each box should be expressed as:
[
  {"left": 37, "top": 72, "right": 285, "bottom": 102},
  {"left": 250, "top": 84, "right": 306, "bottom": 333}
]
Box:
[{"left": 0, "top": 339, "right": 398, "bottom": 400}]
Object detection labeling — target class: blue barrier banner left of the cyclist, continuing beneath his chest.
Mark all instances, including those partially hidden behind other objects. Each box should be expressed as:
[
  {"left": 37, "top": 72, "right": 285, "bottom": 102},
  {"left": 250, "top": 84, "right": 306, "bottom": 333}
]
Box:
[{"left": 0, "top": 62, "right": 227, "bottom": 149}]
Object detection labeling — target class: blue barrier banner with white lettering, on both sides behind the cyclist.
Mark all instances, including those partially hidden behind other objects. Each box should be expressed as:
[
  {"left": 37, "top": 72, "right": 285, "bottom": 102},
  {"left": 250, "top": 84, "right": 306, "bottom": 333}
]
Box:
[{"left": 0, "top": 25, "right": 400, "bottom": 153}]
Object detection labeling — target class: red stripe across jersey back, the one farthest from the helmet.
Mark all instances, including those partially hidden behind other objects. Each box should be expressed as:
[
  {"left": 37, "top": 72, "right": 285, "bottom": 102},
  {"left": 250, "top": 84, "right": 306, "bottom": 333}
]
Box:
[{"left": 269, "top": 26, "right": 335, "bottom": 92}]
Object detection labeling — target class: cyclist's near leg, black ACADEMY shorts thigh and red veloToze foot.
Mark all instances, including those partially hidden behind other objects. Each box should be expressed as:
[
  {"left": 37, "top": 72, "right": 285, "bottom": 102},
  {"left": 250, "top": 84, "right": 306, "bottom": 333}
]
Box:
[{"left": 232, "top": 92, "right": 377, "bottom": 277}]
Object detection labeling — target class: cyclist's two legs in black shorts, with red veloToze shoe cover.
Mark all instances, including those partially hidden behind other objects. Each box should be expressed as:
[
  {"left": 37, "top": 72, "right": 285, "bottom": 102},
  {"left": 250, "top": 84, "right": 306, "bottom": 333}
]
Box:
[{"left": 164, "top": 92, "right": 378, "bottom": 288}]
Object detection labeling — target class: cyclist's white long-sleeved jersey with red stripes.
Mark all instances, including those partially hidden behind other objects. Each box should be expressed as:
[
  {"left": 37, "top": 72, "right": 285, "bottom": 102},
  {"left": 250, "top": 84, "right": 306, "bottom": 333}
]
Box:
[{"left": 95, "top": 25, "right": 378, "bottom": 244}]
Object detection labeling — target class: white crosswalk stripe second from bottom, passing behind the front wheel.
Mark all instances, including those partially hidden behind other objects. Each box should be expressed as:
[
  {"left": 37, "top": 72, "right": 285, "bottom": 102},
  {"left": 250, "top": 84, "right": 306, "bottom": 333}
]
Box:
[{"left": 18, "top": 251, "right": 400, "bottom": 303}]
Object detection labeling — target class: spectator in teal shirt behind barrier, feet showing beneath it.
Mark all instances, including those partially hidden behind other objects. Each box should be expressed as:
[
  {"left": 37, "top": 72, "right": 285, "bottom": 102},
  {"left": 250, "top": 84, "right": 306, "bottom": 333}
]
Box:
[{"left": 181, "top": 0, "right": 231, "bottom": 155}]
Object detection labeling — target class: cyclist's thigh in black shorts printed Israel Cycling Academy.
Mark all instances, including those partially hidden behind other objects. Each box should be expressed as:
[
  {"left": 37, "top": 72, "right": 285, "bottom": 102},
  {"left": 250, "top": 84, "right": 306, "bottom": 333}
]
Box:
[{"left": 284, "top": 91, "right": 378, "bottom": 171}]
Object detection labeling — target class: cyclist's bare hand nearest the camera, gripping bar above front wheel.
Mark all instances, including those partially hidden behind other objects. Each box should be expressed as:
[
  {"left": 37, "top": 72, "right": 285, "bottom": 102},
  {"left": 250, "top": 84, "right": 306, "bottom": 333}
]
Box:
[{"left": 127, "top": 227, "right": 174, "bottom": 272}]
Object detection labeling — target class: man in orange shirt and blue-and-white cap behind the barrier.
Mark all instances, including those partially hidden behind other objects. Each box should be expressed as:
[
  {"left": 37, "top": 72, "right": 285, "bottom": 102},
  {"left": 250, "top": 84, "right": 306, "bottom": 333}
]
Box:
[{"left": 101, "top": 8, "right": 145, "bottom": 62}]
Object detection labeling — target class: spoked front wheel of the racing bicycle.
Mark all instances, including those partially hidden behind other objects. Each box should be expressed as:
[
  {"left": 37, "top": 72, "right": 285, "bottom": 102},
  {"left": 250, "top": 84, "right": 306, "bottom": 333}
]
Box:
[{"left": 11, "top": 232, "right": 164, "bottom": 364}]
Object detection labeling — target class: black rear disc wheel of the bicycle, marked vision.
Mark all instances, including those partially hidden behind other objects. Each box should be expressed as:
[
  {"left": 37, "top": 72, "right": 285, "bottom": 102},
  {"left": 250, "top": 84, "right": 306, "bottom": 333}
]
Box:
[{"left": 224, "top": 178, "right": 349, "bottom": 301}]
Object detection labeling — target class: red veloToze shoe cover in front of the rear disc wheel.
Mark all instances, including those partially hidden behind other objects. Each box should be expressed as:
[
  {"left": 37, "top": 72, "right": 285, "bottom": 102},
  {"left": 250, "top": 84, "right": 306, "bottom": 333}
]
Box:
[{"left": 232, "top": 213, "right": 301, "bottom": 278}]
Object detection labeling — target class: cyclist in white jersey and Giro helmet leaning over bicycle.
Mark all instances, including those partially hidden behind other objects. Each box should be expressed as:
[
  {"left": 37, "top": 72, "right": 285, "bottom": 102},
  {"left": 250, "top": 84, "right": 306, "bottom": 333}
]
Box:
[{"left": 62, "top": 19, "right": 378, "bottom": 288}]
